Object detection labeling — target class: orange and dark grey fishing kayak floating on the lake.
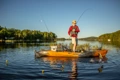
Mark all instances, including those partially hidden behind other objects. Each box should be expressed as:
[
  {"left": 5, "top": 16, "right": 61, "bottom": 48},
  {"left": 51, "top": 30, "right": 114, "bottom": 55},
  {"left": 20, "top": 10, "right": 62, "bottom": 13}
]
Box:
[{"left": 35, "top": 49, "right": 108, "bottom": 57}]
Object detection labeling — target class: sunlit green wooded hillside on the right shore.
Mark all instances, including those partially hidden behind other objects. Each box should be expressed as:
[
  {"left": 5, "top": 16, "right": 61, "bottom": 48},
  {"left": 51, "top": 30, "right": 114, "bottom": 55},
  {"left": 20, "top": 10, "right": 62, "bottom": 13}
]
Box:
[{"left": 98, "top": 30, "right": 120, "bottom": 41}]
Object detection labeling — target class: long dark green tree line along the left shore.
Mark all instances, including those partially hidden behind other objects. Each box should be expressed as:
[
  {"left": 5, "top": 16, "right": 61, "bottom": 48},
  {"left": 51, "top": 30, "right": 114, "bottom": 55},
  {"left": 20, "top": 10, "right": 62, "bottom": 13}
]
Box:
[{"left": 0, "top": 26, "right": 57, "bottom": 40}]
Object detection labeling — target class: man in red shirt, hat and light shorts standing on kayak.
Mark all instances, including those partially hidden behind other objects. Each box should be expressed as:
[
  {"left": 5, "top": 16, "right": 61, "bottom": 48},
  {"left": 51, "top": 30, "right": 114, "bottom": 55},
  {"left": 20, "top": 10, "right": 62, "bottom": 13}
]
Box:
[{"left": 68, "top": 20, "right": 80, "bottom": 52}]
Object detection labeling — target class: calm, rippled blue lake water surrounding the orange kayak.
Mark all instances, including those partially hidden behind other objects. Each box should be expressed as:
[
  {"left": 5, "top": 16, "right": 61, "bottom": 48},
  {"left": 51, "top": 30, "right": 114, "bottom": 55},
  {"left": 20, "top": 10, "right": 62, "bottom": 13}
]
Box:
[{"left": 0, "top": 41, "right": 120, "bottom": 80}]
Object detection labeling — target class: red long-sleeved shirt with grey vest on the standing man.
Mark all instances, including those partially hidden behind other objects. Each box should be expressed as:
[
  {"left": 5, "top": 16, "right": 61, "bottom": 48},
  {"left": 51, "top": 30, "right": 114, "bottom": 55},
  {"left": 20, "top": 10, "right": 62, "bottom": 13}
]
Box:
[{"left": 68, "top": 25, "right": 80, "bottom": 38}]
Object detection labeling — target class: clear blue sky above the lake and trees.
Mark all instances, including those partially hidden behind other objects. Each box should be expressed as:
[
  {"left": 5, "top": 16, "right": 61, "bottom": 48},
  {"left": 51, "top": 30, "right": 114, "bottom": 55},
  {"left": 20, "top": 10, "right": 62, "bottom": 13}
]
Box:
[{"left": 0, "top": 0, "right": 120, "bottom": 38}]
